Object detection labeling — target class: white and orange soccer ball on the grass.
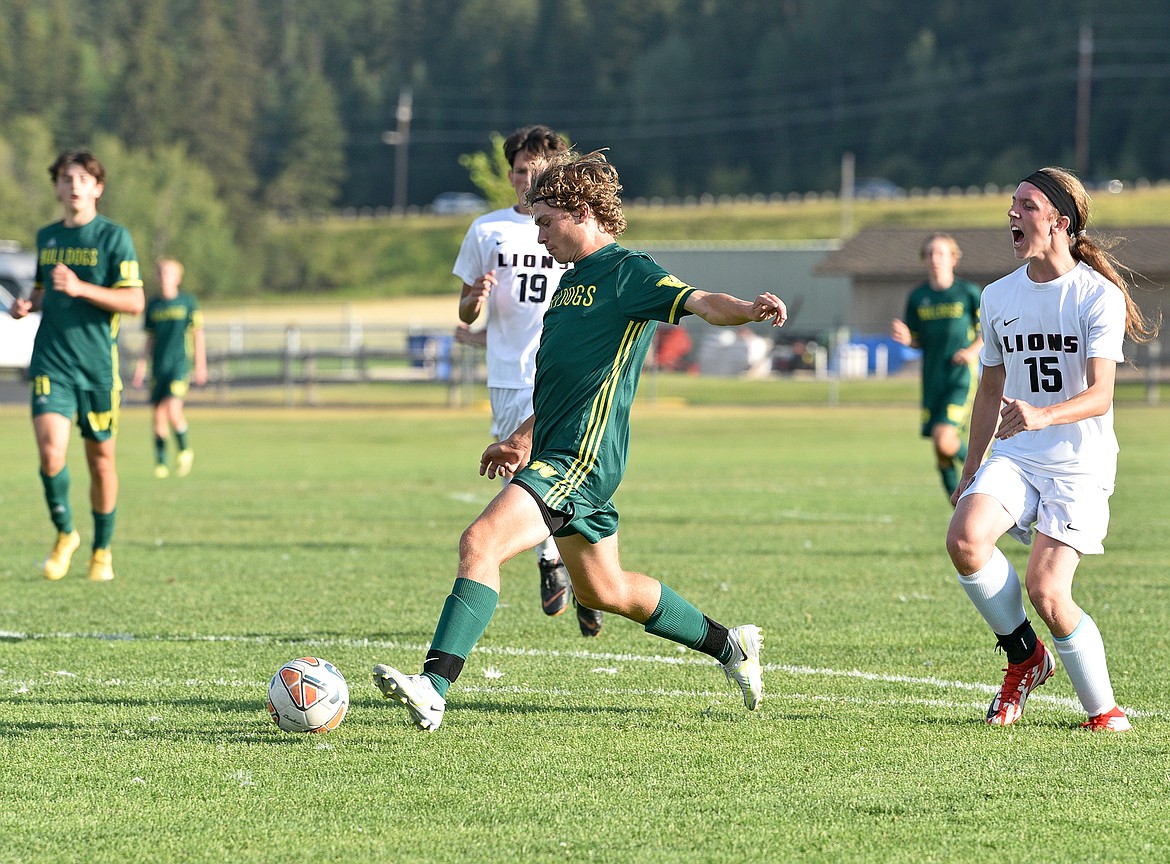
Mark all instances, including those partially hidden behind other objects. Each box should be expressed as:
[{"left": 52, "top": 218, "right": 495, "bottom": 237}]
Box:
[{"left": 268, "top": 657, "right": 350, "bottom": 732}]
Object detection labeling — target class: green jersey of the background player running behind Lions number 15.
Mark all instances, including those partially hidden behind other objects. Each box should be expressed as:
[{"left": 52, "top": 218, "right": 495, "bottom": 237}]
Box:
[{"left": 906, "top": 280, "right": 982, "bottom": 407}]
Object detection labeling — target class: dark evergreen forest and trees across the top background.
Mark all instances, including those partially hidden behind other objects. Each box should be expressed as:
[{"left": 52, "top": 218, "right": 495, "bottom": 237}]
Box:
[{"left": 0, "top": 0, "right": 1170, "bottom": 296}]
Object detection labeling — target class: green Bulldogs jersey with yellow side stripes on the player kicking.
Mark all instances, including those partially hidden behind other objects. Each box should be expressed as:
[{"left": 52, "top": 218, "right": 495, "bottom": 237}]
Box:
[{"left": 532, "top": 244, "right": 695, "bottom": 508}]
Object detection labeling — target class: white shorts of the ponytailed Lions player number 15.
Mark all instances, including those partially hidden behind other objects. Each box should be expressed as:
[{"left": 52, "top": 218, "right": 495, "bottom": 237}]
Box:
[{"left": 962, "top": 455, "right": 1113, "bottom": 555}]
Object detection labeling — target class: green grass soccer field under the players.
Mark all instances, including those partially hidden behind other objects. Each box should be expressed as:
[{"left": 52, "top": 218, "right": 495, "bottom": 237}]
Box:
[{"left": 0, "top": 382, "right": 1170, "bottom": 864}]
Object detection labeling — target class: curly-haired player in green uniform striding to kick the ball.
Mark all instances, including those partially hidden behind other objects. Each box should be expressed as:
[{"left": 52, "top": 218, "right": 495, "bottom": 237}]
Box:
[{"left": 373, "top": 151, "right": 787, "bottom": 731}]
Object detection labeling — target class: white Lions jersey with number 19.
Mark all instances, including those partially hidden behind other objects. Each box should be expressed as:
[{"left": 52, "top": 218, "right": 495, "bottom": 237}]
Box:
[{"left": 453, "top": 207, "right": 570, "bottom": 390}]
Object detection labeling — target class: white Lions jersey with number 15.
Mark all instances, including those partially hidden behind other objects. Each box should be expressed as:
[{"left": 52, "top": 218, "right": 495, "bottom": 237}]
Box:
[{"left": 979, "top": 262, "right": 1126, "bottom": 486}]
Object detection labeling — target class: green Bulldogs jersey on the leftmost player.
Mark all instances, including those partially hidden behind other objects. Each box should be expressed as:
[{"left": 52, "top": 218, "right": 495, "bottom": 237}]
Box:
[{"left": 29, "top": 215, "right": 143, "bottom": 390}]
